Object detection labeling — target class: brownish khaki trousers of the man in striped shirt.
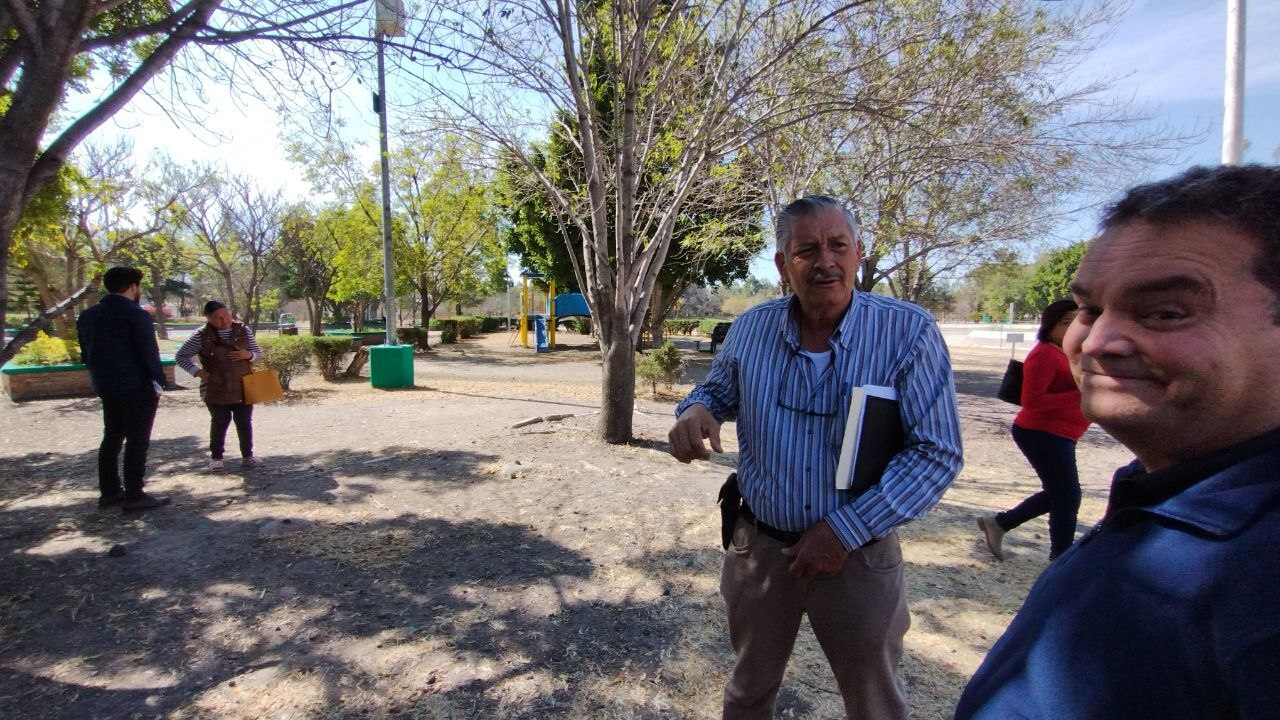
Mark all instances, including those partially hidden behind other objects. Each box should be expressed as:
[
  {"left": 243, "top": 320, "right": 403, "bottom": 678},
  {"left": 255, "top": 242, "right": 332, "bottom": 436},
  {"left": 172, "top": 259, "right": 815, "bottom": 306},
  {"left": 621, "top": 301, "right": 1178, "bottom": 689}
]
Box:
[{"left": 721, "top": 519, "right": 911, "bottom": 720}]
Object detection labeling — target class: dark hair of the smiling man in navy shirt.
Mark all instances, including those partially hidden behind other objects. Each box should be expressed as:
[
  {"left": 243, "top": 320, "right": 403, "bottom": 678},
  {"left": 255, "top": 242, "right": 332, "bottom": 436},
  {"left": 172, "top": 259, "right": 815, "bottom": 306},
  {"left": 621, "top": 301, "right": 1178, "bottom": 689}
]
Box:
[{"left": 1102, "top": 164, "right": 1280, "bottom": 324}]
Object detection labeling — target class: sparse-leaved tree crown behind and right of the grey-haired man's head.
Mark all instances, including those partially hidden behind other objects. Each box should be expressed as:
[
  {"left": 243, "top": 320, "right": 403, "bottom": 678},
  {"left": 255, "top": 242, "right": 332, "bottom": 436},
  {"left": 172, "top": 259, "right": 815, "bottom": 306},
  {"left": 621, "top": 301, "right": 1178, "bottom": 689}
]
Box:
[{"left": 759, "top": 0, "right": 1192, "bottom": 300}]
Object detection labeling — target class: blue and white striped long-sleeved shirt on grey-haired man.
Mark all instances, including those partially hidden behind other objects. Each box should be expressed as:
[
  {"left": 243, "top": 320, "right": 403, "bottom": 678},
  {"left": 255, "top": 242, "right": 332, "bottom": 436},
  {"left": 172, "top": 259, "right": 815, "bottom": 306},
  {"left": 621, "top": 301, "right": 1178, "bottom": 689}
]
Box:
[{"left": 676, "top": 292, "right": 963, "bottom": 550}]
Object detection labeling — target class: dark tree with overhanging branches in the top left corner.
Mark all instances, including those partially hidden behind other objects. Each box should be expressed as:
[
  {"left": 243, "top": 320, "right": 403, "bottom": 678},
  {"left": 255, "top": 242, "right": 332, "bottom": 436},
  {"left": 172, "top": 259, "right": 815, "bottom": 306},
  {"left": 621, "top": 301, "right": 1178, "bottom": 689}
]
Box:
[{"left": 0, "top": 0, "right": 367, "bottom": 363}]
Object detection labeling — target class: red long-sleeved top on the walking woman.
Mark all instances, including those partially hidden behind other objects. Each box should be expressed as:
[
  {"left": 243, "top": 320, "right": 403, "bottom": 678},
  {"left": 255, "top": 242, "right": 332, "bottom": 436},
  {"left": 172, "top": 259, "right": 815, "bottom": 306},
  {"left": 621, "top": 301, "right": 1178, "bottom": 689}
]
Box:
[{"left": 1014, "top": 342, "right": 1089, "bottom": 441}]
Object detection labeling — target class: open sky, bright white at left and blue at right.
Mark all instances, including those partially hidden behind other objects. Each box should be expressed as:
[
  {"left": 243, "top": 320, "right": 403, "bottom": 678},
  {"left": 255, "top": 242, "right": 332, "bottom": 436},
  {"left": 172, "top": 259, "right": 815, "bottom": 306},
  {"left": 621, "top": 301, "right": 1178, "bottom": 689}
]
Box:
[{"left": 85, "top": 0, "right": 1280, "bottom": 278}]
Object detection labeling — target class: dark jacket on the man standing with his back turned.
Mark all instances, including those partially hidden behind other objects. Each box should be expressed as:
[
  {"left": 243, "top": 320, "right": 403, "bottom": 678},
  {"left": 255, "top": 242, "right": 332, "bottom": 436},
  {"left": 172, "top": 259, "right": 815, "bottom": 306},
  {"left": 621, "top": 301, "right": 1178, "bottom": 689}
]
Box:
[{"left": 76, "top": 295, "right": 166, "bottom": 396}]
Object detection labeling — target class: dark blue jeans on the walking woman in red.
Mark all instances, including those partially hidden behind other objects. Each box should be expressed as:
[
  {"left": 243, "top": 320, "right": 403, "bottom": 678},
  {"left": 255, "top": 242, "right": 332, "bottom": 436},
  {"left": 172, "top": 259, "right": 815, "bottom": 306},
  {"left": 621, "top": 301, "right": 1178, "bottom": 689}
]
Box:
[{"left": 996, "top": 425, "right": 1080, "bottom": 559}]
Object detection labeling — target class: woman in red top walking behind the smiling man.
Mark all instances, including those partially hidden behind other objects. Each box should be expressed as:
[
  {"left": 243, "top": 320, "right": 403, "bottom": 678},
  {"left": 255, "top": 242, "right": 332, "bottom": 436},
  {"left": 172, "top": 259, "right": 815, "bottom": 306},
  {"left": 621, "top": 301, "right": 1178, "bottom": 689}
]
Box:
[{"left": 978, "top": 300, "right": 1089, "bottom": 560}]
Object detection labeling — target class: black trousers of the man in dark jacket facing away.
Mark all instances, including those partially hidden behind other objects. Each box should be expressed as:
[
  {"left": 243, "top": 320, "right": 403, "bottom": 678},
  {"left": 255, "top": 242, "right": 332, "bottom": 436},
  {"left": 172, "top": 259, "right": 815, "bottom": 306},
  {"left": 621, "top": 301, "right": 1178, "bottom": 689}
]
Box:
[{"left": 97, "top": 391, "right": 160, "bottom": 496}]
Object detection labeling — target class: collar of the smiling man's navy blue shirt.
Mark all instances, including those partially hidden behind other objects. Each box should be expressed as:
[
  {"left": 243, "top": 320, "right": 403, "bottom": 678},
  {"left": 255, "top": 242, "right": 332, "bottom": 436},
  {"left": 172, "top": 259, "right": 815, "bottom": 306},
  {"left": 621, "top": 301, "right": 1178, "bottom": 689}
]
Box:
[{"left": 1106, "top": 428, "right": 1280, "bottom": 536}]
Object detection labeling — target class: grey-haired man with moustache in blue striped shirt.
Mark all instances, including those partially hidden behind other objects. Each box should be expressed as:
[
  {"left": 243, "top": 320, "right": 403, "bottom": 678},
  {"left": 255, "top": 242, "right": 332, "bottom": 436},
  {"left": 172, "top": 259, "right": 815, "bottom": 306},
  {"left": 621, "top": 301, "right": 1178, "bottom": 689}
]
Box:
[{"left": 669, "top": 196, "right": 961, "bottom": 720}]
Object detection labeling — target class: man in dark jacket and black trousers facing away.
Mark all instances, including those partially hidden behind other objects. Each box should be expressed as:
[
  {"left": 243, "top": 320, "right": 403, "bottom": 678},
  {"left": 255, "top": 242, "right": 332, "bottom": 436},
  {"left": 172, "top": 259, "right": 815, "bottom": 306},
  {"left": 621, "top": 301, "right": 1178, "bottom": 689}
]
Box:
[{"left": 76, "top": 268, "right": 169, "bottom": 510}]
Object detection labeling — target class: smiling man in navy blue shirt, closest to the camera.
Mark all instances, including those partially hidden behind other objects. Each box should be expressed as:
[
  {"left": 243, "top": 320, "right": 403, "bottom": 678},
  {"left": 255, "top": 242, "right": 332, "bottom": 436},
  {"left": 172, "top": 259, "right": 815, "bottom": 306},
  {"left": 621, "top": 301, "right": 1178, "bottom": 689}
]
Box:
[{"left": 956, "top": 165, "right": 1280, "bottom": 720}]
